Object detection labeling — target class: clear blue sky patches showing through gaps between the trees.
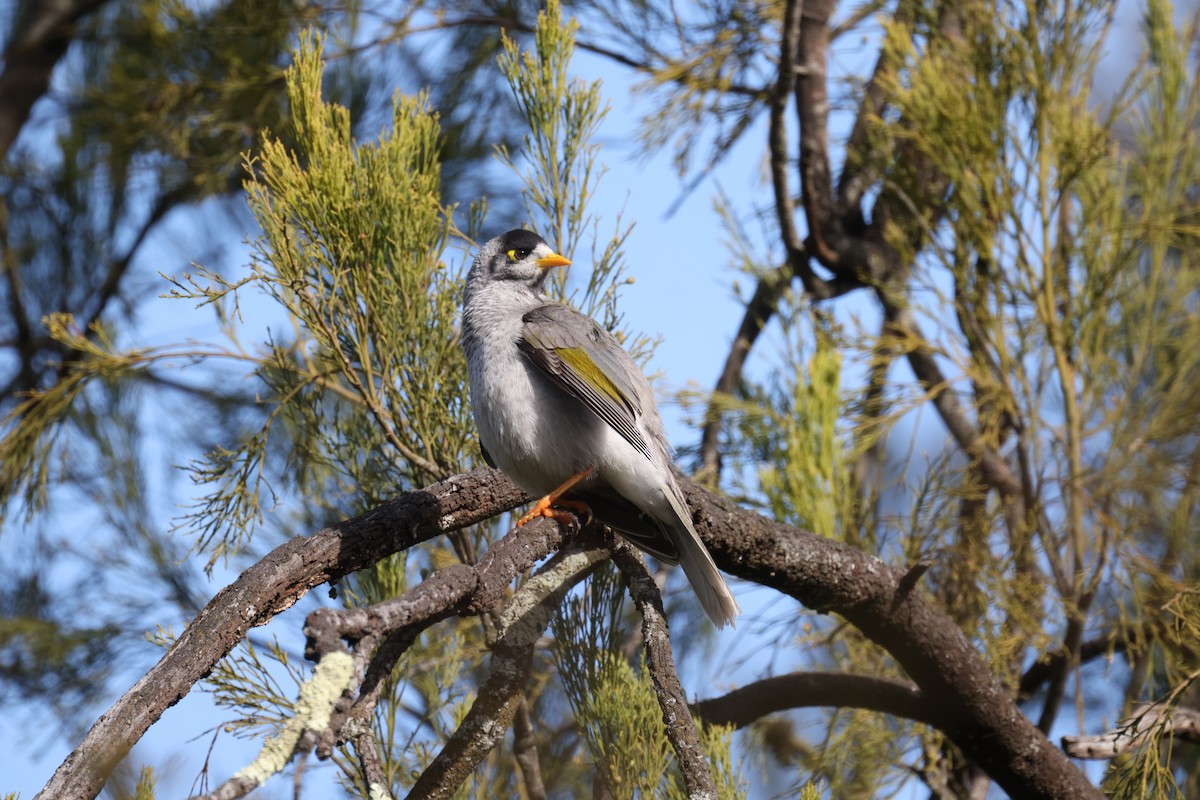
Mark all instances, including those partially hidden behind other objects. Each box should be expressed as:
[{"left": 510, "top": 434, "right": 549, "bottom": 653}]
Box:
[{"left": 0, "top": 4, "right": 1147, "bottom": 799}]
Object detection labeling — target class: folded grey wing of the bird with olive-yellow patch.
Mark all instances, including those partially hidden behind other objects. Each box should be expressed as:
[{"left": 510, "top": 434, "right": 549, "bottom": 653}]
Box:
[{"left": 517, "top": 303, "right": 654, "bottom": 459}]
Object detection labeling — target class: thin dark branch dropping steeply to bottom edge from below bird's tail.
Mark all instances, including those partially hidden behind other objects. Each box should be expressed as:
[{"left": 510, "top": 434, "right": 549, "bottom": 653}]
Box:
[{"left": 612, "top": 539, "right": 716, "bottom": 800}]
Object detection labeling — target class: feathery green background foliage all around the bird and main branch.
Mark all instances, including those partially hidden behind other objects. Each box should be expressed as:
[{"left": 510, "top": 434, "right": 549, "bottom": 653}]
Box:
[{"left": 0, "top": 0, "right": 1200, "bottom": 798}]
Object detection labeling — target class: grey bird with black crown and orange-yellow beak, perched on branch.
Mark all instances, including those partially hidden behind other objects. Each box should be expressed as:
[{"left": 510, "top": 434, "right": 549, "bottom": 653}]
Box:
[{"left": 462, "top": 230, "right": 740, "bottom": 627}]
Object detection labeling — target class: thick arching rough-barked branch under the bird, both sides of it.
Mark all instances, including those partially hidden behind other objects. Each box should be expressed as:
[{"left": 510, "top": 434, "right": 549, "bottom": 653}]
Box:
[{"left": 38, "top": 469, "right": 1100, "bottom": 800}]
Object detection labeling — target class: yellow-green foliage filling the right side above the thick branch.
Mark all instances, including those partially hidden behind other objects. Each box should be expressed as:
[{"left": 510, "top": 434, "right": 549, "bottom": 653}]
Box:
[{"left": 686, "top": 2, "right": 1200, "bottom": 796}]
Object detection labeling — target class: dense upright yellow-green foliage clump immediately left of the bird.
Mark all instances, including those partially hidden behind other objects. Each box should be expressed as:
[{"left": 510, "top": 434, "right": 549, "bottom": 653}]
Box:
[{"left": 175, "top": 29, "right": 469, "bottom": 565}]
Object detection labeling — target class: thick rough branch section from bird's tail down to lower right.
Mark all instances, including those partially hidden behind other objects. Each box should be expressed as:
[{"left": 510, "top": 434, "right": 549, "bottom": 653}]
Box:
[{"left": 680, "top": 480, "right": 1102, "bottom": 800}]
